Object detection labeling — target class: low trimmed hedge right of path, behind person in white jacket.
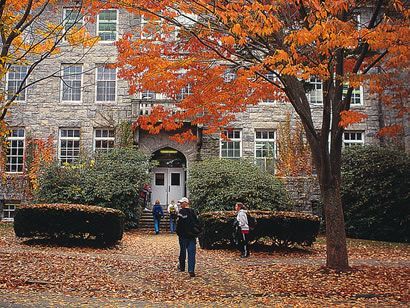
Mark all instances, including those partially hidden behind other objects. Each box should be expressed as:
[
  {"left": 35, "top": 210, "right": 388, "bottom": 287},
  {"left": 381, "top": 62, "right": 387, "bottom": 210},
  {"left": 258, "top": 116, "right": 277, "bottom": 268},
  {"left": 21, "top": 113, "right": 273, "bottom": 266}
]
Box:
[{"left": 199, "top": 211, "right": 320, "bottom": 249}]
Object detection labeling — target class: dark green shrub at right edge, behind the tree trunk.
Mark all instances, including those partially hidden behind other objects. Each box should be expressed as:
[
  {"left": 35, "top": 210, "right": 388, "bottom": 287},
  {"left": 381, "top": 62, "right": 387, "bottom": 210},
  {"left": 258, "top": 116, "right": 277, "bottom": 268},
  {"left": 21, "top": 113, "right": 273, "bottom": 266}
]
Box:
[{"left": 341, "top": 146, "right": 410, "bottom": 242}]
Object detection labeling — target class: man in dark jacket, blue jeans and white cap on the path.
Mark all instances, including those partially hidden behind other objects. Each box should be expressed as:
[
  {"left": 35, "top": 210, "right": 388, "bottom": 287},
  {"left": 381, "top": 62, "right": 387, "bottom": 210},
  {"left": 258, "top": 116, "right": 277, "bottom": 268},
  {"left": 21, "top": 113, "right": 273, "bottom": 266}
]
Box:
[{"left": 177, "top": 197, "right": 201, "bottom": 277}]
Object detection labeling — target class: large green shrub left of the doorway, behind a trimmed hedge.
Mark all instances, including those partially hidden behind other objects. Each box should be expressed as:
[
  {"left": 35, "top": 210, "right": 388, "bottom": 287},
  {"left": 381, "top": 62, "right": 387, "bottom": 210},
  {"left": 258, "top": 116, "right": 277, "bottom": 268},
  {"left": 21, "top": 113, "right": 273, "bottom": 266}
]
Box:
[{"left": 36, "top": 148, "right": 150, "bottom": 228}]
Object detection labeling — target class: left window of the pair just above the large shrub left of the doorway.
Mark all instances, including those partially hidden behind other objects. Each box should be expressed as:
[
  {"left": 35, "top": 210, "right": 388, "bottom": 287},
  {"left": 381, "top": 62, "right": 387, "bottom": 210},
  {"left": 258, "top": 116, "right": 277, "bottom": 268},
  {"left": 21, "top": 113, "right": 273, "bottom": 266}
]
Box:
[{"left": 58, "top": 128, "right": 80, "bottom": 163}]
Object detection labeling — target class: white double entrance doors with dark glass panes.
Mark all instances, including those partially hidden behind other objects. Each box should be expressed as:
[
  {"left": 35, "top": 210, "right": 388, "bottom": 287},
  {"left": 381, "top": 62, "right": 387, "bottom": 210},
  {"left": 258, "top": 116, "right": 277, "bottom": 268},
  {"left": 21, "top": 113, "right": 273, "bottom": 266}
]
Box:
[{"left": 151, "top": 168, "right": 185, "bottom": 204}]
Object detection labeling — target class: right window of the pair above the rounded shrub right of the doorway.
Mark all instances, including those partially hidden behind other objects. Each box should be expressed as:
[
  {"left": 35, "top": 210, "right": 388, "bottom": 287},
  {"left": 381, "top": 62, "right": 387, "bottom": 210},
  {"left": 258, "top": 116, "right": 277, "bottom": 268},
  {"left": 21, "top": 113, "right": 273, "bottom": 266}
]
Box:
[{"left": 255, "top": 129, "right": 276, "bottom": 174}]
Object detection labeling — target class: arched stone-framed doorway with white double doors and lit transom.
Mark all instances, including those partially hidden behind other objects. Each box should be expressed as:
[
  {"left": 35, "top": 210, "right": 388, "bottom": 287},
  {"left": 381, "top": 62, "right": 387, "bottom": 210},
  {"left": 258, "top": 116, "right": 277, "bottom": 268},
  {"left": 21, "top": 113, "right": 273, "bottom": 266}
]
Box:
[{"left": 151, "top": 147, "right": 186, "bottom": 204}]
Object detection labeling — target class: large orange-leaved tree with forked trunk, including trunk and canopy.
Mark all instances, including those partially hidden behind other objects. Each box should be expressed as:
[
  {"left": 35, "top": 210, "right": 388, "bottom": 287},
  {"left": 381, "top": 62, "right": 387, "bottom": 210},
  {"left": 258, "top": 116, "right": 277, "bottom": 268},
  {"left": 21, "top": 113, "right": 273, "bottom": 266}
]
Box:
[{"left": 113, "top": 0, "right": 410, "bottom": 270}]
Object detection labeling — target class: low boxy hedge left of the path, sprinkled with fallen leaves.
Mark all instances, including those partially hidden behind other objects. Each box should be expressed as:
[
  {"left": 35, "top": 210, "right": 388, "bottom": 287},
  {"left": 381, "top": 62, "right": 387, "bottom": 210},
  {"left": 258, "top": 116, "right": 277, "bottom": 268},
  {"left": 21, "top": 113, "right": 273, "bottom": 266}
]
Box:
[{"left": 14, "top": 204, "right": 125, "bottom": 246}]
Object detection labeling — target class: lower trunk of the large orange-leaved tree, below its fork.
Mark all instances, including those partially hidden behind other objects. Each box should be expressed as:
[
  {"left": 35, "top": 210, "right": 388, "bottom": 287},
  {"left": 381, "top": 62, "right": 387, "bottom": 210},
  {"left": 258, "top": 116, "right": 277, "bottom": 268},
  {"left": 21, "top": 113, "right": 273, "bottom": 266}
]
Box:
[{"left": 320, "top": 179, "right": 349, "bottom": 271}]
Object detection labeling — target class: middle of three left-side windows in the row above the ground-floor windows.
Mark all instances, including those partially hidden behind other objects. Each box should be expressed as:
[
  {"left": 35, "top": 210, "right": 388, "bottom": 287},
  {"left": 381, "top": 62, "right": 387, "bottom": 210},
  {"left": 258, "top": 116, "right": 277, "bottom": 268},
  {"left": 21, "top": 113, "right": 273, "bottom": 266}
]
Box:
[{"left": 61, "top": 64, "right": 83, "bottom": 102}]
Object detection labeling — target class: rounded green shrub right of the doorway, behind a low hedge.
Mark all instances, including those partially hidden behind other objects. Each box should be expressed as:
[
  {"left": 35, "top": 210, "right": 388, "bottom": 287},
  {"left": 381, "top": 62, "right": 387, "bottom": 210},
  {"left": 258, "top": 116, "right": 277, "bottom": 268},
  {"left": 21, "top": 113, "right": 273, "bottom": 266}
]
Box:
[{"left": 188, "top": 158, "right": 290, "bottom": 213}]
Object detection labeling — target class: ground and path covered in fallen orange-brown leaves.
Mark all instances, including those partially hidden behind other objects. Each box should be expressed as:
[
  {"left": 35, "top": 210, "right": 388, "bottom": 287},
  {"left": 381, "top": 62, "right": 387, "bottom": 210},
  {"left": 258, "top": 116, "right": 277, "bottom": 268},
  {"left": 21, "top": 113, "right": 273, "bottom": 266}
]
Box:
[{"left": 0, "top": 223, "right": 410, "bottom": 307}]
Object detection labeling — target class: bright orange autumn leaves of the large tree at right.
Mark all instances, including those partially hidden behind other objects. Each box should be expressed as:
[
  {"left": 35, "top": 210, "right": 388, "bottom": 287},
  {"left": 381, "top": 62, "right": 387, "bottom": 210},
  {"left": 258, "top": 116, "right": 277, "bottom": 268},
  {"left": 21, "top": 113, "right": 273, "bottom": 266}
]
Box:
[{"left": 111, "top": 0, "right": 410, "bottom": 142}]
